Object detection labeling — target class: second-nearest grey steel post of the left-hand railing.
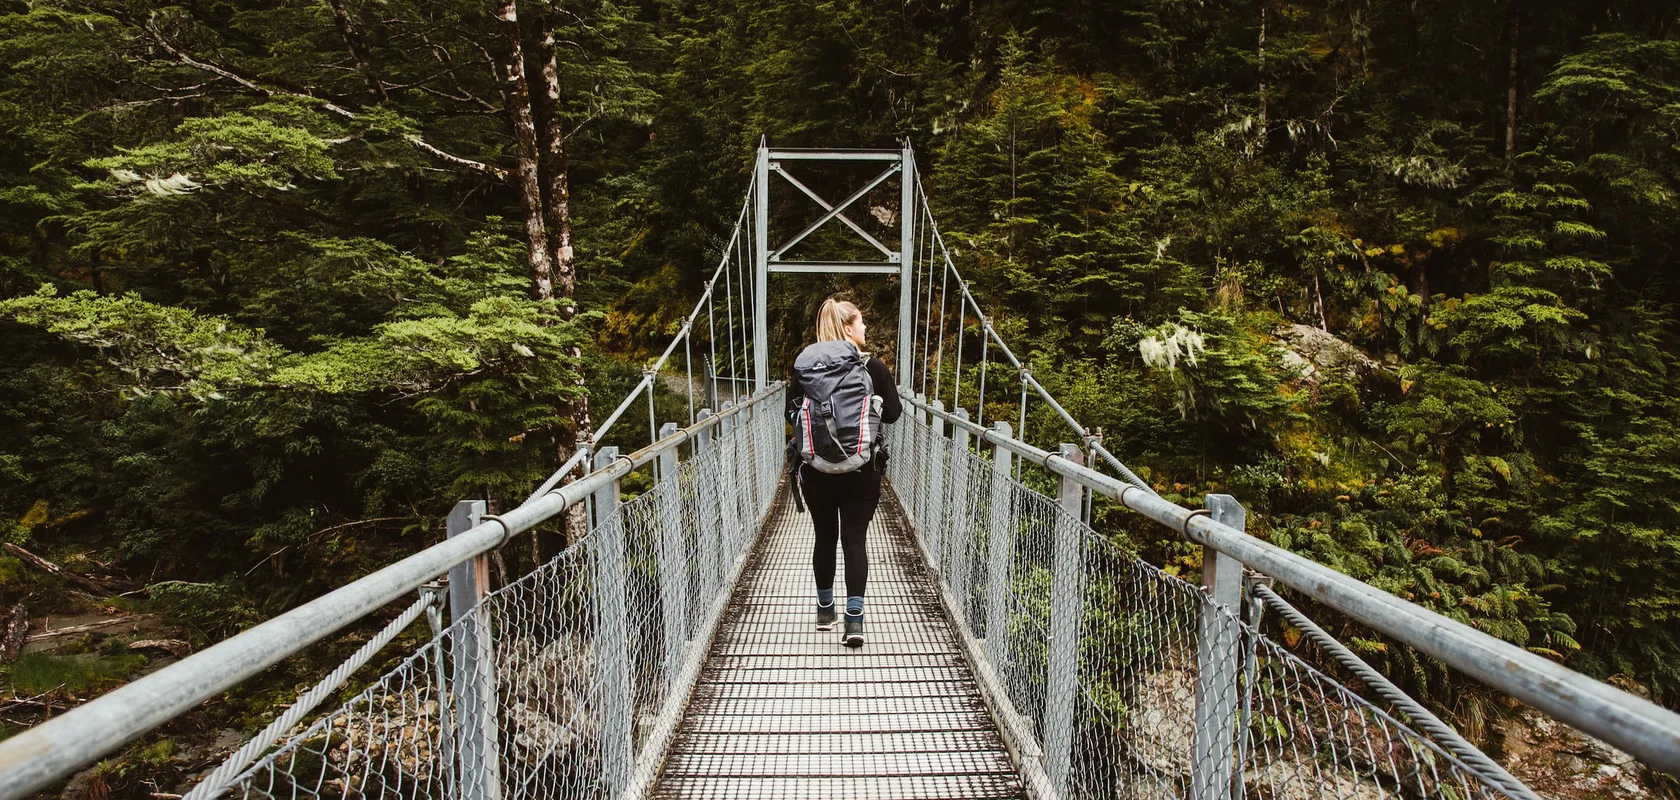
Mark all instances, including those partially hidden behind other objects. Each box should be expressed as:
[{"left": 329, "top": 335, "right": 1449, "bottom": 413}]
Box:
[{"left": 591, "top": 445, "right": 635, "bottom": 797}]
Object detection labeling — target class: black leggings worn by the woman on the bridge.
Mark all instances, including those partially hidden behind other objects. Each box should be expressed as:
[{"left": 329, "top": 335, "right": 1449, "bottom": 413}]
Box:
[{"left": 800, "top": 466, "right": 880, "bottom": 597}]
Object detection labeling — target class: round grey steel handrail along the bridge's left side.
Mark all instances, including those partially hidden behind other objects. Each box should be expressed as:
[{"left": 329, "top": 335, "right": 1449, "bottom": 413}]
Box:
[{"left": 0, "top": 383, "right": 781, "bottom": 800}]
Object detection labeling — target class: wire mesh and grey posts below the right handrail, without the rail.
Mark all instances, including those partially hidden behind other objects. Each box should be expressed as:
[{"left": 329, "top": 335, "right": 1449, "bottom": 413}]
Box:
[{"left": 889, "top": 398, "right": 1529, "bottom": 800}]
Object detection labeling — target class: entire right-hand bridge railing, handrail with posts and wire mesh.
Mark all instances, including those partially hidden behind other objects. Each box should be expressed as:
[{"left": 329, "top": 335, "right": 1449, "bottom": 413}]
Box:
[{"left": 889, "top": 397, "right": 1680, "bottom": 800}]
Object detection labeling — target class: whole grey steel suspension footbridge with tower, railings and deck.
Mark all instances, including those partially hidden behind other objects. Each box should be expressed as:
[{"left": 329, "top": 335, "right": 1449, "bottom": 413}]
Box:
[{"left": 0, "top": 145, "right": 1680, "bottom": 800}]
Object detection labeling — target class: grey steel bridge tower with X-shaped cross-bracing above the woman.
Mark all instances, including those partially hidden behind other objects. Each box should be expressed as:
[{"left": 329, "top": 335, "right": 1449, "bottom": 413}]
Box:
[{"left": 753, "top": 139, "right": 917, "bottom": 390}]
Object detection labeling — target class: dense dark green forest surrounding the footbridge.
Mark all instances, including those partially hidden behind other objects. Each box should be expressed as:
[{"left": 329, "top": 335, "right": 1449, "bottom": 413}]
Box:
[{"left": 0, "top": 0, "right": 1680, "bottom": 797}]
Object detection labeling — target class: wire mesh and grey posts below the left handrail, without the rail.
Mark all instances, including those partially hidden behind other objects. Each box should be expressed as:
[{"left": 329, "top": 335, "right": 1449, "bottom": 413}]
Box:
[{"left": 212, "top": 390, "right": 783, "bottom": 800}]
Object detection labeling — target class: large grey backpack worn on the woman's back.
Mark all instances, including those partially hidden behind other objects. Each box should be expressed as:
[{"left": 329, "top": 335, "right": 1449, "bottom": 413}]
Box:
[{"left": 793, "top": 341, "right": 880, "bottom": 474}]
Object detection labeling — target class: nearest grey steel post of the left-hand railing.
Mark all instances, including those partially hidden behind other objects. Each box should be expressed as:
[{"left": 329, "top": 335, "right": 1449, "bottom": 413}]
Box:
[{"left": 447, "top": 501, "right": 502, "bottom": 800}]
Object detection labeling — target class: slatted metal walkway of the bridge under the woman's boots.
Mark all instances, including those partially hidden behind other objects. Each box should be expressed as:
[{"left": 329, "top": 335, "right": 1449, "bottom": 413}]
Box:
[{"left": 654, "top": 484, "right": 1025, "bottom": 800}]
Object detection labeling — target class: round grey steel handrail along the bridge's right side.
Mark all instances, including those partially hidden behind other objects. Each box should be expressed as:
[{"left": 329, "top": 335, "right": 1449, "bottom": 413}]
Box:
[{"left": 904, "top": 389, "right": 1680, "bottom": 775}]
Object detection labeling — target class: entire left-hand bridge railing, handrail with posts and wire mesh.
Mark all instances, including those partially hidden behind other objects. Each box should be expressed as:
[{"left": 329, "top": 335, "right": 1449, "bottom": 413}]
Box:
[{"left": 0, "top": 385, "right": 785, "bottom": 800}]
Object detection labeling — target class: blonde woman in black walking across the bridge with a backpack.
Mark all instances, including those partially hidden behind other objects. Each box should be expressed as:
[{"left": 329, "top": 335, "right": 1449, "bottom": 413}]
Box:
[{"left": 788, "top": 297, "right": 904, "bottom": 647}]
